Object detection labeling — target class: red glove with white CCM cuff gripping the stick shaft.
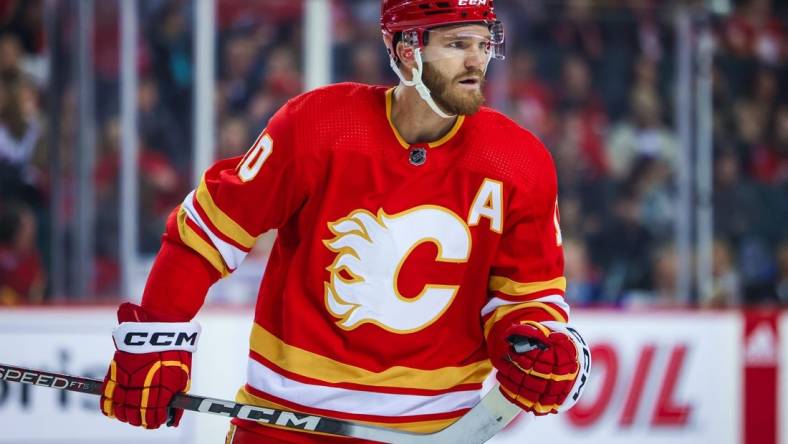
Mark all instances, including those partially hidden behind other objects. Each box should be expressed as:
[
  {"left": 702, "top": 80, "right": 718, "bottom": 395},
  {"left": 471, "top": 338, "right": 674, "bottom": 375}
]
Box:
[{"left": 100, "top": 303, "right": 200, "bottom": 429}]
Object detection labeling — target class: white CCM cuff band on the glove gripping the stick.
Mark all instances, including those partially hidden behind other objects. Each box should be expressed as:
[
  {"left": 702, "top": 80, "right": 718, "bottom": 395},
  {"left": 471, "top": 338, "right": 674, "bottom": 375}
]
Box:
[{"left": 112, "top": 322, "right": 200, "bottom": 353}]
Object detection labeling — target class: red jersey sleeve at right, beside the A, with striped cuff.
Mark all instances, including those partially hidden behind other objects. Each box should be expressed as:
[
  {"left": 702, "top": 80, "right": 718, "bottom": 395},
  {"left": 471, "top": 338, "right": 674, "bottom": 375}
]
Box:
[{"left": 481, "top": 144, "right": 569, "bottom": 337}]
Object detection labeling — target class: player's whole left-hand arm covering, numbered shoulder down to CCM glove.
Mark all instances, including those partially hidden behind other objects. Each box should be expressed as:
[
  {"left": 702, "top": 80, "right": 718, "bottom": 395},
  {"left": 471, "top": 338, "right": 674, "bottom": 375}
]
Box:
[{"left": 142, "top": 102, "right": 310, "bottom": 319}]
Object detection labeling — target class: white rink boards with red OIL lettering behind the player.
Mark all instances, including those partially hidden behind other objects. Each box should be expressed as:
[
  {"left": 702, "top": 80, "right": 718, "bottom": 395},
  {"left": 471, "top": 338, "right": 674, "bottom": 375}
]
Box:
[{"left": 0, "top": 308, "right": 788, "bottom": 444}]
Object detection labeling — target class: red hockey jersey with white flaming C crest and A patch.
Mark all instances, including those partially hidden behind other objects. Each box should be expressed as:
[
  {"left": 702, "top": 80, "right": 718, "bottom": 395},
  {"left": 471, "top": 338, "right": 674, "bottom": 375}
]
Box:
[{"left": 152, "top": 84, "right": 569, "bottom": 440}]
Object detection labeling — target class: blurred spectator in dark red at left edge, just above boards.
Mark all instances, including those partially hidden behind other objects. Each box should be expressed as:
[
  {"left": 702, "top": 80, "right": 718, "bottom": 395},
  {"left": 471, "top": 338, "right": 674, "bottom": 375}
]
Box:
[{"left": 0, "top": 201, "right": 46, "bottom": 305}]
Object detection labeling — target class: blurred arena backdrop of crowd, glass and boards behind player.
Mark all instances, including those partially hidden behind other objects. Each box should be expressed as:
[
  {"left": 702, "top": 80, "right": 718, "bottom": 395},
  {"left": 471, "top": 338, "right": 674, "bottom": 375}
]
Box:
[{"left": 0, "top": 0, "right": 788, "bottom": 444}]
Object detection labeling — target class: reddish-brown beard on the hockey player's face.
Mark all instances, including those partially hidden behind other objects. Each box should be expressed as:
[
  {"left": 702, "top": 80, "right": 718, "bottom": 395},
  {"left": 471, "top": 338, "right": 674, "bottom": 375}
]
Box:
[{"left": 422, "top": 63, "right": 484, "bottom": 116}]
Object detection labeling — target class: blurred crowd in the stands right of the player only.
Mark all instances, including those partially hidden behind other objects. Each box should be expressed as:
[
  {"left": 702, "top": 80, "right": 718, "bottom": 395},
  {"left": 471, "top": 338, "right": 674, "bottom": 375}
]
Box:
[{"left": 486, "top": 0, "right": 788, "bottom": 307}]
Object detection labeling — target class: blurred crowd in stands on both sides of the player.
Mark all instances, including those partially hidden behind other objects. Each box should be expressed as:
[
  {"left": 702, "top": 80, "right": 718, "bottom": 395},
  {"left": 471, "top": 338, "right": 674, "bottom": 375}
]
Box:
[{"left": 0, "top": 0, "right": 788, "bottom": 307}]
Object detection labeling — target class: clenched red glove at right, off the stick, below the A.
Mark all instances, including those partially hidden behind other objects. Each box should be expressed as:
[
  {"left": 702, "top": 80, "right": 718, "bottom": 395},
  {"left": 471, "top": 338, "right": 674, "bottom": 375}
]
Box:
[{"left": 488, "top": 321, "right": 591, "bottom": 415}]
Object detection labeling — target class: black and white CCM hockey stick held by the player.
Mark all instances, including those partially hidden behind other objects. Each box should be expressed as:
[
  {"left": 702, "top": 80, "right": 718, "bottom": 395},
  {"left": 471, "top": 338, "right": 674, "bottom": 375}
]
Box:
[{"left": 0, "top": 364, "right": 521, "bottom": 444}]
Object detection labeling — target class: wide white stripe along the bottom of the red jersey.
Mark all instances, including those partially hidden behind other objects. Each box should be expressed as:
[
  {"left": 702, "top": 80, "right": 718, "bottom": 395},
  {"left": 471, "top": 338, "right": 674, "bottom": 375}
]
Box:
[{"left": 247, "top": 359, "right": 481, "bottom": 417}]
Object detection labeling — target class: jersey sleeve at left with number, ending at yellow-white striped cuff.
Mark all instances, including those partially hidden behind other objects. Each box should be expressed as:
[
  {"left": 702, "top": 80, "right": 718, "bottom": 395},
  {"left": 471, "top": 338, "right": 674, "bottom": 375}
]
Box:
[{"left": 168, "top": 100, "right": 307, "bottom": 276}]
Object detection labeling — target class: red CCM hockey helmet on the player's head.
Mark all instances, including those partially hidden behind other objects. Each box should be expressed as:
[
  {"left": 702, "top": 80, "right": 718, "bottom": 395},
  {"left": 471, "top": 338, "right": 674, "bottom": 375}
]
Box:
[{"left": 380, "top": 0, "right": 503, "bottom": 58}]
